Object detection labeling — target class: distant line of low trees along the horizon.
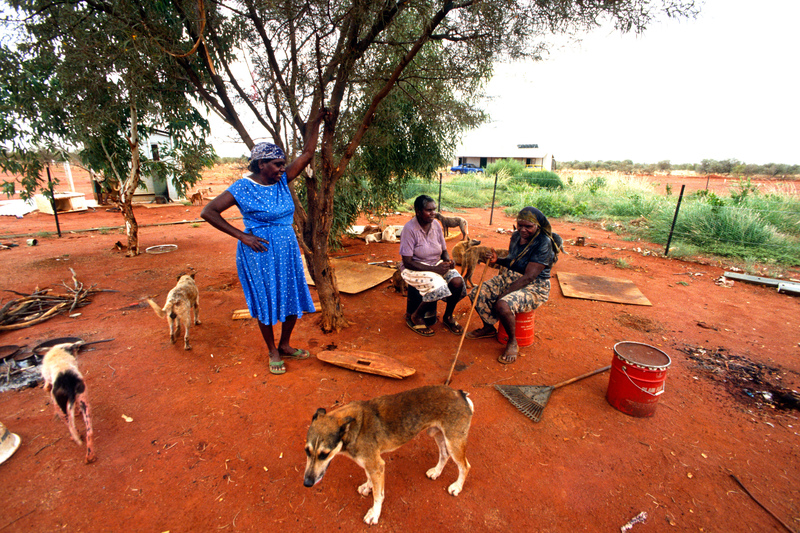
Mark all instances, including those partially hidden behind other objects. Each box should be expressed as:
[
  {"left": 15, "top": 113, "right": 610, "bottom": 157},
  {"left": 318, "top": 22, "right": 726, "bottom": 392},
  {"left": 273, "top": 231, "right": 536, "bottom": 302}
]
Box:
[{"left": 556, "top": 159, "right": 800, "bottom": 176}]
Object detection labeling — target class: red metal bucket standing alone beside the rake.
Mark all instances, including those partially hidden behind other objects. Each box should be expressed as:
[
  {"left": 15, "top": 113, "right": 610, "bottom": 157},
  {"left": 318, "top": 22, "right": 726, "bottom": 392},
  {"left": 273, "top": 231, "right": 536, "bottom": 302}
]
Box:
[{"left": 606, "top": 342, "right": 672, "bottom": 418}]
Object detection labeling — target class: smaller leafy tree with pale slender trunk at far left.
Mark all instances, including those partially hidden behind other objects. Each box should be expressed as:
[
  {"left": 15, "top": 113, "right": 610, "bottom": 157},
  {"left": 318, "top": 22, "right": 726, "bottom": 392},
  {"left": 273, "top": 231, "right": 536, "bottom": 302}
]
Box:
[{"left": 0, "top": 0, "right": 214, "bottom": 256}]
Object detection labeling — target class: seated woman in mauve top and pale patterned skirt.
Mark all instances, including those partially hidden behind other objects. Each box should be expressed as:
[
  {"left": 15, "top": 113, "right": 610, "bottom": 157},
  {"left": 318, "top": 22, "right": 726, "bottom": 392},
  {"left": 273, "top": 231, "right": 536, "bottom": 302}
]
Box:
[{"left": 399, "top": 194, "right": 467, "bottom": 337}]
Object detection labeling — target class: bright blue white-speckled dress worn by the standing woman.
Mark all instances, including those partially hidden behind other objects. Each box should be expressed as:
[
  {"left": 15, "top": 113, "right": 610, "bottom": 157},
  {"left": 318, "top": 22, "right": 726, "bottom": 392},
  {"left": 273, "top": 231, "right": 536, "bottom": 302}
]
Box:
[{"left": 228, "top": 173, "right": 315, "bottom": 325}]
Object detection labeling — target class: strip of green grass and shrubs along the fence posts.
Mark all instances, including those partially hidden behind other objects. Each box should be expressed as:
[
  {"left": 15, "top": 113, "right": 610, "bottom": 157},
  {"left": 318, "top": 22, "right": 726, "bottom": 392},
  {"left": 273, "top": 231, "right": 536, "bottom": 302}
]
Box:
[{"left": 403, "top": 173, "right": 800, "bottom": 265}]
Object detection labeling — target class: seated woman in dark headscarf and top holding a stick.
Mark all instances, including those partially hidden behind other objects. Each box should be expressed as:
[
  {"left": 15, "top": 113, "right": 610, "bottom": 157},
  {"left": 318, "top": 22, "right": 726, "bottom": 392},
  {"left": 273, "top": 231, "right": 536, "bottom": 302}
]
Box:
[{"left": 467, "top": 207, "right": 562, "bottom": 364}]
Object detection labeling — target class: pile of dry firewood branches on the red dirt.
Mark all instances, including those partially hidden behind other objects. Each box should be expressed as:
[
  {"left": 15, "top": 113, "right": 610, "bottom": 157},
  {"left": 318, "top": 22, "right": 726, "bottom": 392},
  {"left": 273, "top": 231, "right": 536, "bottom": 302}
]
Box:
[{"left": 0, "top": 268, "right": 103, "bottom": 331}]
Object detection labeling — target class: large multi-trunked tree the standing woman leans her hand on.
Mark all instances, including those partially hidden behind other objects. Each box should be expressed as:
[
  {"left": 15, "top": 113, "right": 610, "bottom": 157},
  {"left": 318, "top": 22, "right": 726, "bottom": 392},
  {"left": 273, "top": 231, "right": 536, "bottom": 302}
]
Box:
[{"left": 3, "top": 0, "right": 696, "bottom": 331}]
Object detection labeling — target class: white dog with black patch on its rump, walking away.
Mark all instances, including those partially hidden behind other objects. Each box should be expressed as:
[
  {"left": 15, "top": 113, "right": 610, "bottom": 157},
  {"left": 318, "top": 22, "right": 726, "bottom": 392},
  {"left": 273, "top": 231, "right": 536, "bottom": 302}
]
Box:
[{"left": 42, "top": 344, "right": 96, "bottom": 464}]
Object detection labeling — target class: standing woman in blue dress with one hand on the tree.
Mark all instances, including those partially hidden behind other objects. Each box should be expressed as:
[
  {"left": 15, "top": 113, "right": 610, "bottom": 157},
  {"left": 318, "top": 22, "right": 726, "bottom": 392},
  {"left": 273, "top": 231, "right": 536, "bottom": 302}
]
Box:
[{"left": 200, "top": 111, "right": 325, "bottom": 374}]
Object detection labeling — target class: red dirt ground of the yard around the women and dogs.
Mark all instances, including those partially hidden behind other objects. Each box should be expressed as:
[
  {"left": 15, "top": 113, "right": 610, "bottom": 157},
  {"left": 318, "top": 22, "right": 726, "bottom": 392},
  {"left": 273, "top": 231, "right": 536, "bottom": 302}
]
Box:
[{"left": 0, "top": 164, "right": 800, "bottom": 533}]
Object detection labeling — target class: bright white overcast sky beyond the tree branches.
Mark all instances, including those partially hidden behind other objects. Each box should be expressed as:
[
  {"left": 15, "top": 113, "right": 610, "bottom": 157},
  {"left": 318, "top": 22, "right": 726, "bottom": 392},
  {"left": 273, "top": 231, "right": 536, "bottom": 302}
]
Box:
[{"left": 213, "top": 0, "right": 800, "bottom": 164}]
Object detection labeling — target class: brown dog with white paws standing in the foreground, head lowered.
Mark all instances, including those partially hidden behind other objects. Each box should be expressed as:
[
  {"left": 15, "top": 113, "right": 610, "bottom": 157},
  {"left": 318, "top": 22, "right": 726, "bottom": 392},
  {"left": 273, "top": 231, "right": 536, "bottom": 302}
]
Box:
[{"left": 303, "top": 385, "right": 475, "bottom": 525}]
